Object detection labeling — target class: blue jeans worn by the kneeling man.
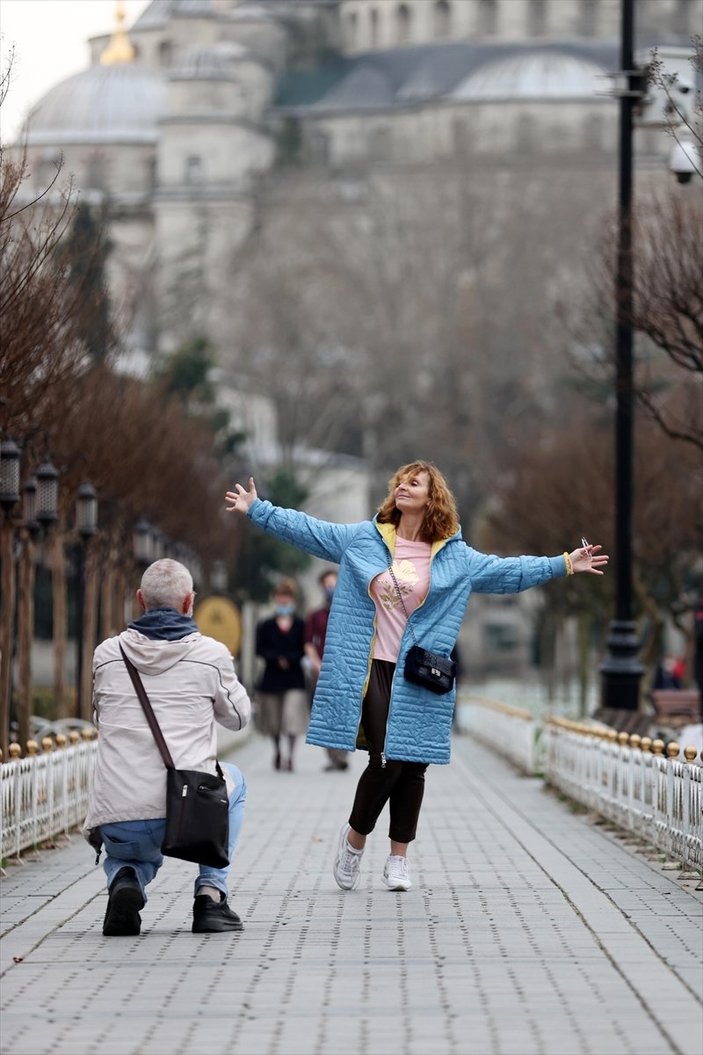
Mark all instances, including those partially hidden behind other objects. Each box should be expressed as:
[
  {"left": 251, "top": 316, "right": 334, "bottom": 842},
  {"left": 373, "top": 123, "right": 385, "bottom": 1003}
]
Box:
[{"left": 100, "top": 762, "right": 247, "bottom": 902}]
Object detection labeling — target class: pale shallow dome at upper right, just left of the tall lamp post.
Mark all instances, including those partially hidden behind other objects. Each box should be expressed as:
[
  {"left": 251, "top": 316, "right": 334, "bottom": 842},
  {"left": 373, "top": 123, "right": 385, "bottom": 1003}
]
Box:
[{"left": 451, "top": 51, "right": 606, "bottom": 102}]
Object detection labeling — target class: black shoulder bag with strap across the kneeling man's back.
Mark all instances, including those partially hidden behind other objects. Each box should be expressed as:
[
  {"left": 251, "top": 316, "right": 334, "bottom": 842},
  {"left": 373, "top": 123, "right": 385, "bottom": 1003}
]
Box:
[{"left": 119, "top": 645, "right": 229, "bottom": 868}]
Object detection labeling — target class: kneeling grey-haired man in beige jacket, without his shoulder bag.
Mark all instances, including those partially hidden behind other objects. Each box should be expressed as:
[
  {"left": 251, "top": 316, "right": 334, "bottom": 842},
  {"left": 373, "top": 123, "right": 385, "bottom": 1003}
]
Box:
[{"left": 83, "top": 559, "right": 251, "bottom": 937}]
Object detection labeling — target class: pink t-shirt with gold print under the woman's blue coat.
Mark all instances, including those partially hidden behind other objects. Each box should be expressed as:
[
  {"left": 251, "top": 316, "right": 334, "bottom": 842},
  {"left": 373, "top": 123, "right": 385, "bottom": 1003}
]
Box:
[{"left": 371, "top": 537, "right": 432, "bottom": 663}]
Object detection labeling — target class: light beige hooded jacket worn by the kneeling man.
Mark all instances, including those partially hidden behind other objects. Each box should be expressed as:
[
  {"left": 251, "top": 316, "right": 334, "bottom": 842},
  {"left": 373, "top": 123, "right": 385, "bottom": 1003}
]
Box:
[{"left": 83, "top": 629, "right": 251, "bottom": 838}]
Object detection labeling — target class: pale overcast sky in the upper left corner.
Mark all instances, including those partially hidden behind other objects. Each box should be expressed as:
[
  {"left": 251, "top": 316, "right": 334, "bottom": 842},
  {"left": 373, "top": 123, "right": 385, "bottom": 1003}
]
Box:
[{"left": 0, "top": 0, "right": 149, "bottom": 142}]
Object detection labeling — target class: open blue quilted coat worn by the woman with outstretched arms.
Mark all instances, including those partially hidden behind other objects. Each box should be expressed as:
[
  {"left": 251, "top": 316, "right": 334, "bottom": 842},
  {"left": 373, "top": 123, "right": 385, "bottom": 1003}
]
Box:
[{"left": 248, "top": 499, "right": 566, "bottom": 763}]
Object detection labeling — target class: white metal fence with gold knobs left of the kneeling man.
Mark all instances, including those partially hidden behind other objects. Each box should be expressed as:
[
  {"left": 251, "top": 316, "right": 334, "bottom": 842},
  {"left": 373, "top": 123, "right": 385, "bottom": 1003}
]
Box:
[{"left": 0, "top": 734, "right": 97, "bottom": 860}]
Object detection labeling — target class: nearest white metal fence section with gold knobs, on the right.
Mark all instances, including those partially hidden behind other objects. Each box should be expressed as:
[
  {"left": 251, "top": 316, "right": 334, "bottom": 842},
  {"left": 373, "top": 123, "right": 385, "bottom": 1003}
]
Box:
[{"left": 544, "top": 718, "right": 703, "bottom": 870}]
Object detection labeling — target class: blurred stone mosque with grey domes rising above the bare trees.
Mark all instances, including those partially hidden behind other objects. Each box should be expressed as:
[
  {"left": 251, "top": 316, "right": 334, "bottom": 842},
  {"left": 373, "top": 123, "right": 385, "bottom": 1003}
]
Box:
[{"left": 23, "top": 0, "right": 702, "bottom": 371}]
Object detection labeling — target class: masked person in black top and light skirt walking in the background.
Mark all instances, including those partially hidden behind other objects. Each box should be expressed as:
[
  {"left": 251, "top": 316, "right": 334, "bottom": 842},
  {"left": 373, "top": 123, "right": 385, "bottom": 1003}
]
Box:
[{"left": 257, "top": 579, "right": 308, "bottom": 772}]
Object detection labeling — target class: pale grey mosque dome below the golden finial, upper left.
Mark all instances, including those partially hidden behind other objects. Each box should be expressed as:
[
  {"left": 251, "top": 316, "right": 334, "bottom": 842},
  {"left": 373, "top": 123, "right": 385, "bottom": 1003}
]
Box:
[{"left": 25, "top": 62, "right": 166, "bottom": 147}]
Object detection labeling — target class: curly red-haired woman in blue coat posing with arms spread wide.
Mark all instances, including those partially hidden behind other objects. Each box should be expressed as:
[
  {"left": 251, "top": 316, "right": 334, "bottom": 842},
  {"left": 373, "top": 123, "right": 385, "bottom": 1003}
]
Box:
[{"left": 226, "top": 461, "right": 608, "bottom": 890}]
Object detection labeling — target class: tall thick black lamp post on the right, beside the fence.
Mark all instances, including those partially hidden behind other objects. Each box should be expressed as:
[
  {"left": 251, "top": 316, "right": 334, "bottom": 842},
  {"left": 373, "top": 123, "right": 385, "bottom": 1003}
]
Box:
[{"left": 601, "top": 0, "right": 645, "bottom": 711}]
